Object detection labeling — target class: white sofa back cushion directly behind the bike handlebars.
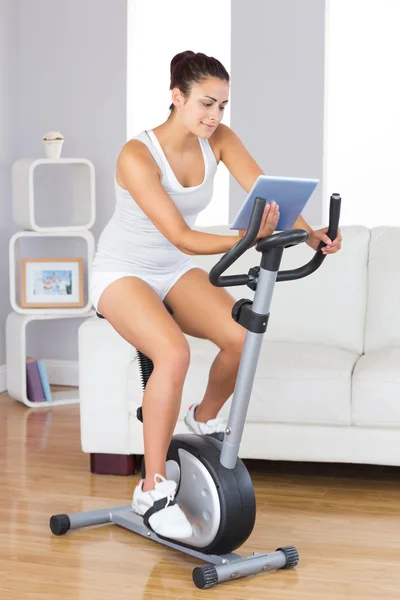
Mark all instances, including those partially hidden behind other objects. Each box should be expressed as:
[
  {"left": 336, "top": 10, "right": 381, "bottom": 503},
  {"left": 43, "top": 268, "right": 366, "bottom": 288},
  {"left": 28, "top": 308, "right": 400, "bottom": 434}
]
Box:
[{"left": 193, "top": 226, "right": 368, "bottom": 354}]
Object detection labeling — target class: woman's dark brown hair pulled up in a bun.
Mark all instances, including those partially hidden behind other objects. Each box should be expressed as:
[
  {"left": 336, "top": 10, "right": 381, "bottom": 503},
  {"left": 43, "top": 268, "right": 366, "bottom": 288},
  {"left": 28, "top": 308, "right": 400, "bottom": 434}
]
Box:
[{"left": 169, "top": 50, "right": 230, "bottom": 110}]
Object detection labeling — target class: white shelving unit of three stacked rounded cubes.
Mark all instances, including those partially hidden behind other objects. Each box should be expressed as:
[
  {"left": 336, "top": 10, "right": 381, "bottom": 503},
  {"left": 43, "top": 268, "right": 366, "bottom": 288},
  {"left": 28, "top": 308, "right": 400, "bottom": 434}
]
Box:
[{"left": 6, "top": 158, "right": 96, "bottom": 408}]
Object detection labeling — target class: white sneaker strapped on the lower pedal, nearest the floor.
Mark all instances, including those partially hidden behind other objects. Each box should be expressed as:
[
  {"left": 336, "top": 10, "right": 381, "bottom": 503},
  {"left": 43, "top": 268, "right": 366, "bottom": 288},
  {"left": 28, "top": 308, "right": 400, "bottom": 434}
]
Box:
[{"left": 132, "top": 474, "right": 193, "bottom": 539}]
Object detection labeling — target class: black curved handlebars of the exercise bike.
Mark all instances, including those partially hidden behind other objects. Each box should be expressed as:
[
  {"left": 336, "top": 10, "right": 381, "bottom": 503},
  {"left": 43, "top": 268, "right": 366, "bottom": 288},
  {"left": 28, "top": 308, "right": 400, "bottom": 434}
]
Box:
[{"left": 209, "top": 194, "right": 341, "bottom": 287}]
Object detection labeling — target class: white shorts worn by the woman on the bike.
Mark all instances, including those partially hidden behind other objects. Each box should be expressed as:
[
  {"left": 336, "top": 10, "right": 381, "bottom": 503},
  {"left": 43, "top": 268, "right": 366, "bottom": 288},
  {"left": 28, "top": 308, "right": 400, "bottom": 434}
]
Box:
[{"left": 89, "top": 261, "right": 196, "bottom": 311}]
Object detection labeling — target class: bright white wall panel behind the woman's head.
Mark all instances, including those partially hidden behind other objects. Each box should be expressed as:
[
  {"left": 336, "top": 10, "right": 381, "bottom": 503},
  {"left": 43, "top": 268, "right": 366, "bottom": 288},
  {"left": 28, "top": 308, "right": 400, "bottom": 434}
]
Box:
[{"left": 127, "top": 0, "right": 231, "bottom": 226}]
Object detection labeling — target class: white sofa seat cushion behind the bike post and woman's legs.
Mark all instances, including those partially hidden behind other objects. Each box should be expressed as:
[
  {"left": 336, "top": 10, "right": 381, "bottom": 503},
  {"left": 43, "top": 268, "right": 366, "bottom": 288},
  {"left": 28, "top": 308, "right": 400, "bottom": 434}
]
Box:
[{"left": 129, "top": 336, "right": 358, "bottom": 425}]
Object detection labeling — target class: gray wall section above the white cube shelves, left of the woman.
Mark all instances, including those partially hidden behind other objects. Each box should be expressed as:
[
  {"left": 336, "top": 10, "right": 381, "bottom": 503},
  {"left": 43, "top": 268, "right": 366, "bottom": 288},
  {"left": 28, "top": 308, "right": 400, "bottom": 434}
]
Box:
[{"left": 16, "top": 0, "right": 127, "bottom": 241}]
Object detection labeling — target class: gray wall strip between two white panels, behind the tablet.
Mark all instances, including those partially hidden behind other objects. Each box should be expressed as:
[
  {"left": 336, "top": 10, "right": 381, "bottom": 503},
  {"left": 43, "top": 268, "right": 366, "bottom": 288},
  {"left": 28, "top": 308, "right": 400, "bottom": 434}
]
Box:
[{"left": 230, "top": 0, "right": 325, "bottom": 225}]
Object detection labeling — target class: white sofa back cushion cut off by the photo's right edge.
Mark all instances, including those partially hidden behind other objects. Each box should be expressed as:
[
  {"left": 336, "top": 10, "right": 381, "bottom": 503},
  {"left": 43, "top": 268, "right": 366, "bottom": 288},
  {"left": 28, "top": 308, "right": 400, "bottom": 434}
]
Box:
[{"left": 365, "top": 227, "right": 400, "bottom": 352}]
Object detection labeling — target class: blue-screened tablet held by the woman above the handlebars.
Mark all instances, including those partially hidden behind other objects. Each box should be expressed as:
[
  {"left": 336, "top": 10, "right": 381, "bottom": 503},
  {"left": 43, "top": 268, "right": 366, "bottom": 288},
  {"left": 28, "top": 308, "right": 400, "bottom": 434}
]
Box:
[{"left": 230, "top": 175, "right": 319, "bottom": 231}]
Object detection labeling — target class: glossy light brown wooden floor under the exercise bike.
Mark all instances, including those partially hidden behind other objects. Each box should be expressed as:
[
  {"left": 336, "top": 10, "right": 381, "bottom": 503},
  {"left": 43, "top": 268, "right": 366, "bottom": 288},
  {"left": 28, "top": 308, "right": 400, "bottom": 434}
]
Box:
[{"left": 0, "top": 394, "right": 400, "bottom": 600}]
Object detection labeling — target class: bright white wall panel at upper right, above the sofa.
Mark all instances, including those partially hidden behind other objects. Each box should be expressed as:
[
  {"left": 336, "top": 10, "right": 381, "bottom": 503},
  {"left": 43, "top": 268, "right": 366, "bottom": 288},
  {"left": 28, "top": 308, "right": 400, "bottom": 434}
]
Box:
[{"left": 325, "top": 0, "right": 400, "bottom": 227}]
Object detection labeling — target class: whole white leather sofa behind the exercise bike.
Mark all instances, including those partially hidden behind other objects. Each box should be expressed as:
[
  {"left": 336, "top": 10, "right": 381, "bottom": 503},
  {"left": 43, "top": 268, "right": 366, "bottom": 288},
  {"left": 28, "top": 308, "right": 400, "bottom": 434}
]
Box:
[{"left": 79, "top": 226, "right": 400, "bottom": 472}]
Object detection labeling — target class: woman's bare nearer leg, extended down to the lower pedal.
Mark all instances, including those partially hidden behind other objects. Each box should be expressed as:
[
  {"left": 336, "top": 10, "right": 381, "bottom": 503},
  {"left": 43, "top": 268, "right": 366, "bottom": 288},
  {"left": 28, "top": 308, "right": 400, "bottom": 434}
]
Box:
[{"left": 98, "top": 277, "right": 190, "bottom": 491}]
